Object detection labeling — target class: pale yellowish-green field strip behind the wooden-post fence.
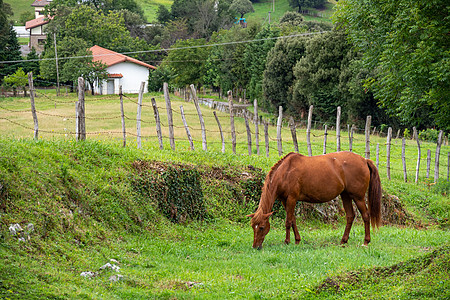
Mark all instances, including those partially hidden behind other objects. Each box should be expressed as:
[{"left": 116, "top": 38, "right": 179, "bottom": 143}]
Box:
[{"left": 0, "top": 75, "right": 450, "bottom": 182}]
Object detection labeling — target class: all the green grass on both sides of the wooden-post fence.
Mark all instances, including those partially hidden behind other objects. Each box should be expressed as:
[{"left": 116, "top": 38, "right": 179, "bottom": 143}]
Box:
[{"left": 0, "top": 91, "right": 450, "bottom": 299}]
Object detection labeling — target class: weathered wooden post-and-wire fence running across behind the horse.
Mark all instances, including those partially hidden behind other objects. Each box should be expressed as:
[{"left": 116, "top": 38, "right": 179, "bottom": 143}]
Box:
[{"left": 0, "top": 74, "right": 450, "bottom": 182}]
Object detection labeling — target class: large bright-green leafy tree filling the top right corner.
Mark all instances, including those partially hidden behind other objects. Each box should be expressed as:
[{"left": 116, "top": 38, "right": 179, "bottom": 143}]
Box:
[{"left": 334, "top": 0, "right": 450, "bottom": 130}]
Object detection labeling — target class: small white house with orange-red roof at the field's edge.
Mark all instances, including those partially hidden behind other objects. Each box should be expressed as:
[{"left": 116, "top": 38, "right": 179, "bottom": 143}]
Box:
[{"left": 89, "top": 45, "right": 156, "bottom": 95}]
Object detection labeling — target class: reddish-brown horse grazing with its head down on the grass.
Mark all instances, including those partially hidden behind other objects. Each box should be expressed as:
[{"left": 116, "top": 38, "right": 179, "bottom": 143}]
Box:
[{"left": 247, "top": 151, "right": 381, "bottom": 249}]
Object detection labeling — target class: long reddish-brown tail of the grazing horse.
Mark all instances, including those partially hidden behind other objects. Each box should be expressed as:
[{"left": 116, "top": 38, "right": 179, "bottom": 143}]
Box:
[{"left": 366, "top": 159, "right": 381, "bottom": 228}]
